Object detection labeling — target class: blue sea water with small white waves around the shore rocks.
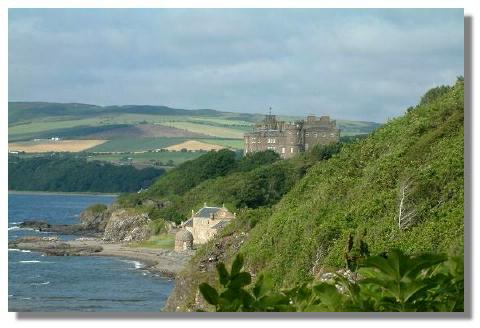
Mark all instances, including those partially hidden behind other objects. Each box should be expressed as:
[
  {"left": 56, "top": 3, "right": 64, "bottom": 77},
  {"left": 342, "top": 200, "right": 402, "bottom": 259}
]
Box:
[{"left": 8, "top": 193, "right": 174, "bottom": 312}]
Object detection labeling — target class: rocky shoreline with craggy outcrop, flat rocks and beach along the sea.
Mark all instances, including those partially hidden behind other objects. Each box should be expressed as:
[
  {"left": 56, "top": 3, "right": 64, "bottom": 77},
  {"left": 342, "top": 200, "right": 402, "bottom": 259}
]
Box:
[{"left": 8, "top": 204, "right": 194, "bottom": 277}]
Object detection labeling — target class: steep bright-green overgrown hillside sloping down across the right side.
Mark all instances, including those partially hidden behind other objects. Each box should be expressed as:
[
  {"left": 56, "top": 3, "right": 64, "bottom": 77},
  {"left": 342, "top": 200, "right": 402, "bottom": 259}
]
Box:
[{"left": 160, "top": 79, "right": 464, "bottom": 310}]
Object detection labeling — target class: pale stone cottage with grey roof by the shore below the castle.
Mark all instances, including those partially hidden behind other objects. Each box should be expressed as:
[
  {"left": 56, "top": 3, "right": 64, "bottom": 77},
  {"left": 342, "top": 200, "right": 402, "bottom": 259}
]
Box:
[{"left": 175, "top": 203, "right": 235, "bottom": 251}]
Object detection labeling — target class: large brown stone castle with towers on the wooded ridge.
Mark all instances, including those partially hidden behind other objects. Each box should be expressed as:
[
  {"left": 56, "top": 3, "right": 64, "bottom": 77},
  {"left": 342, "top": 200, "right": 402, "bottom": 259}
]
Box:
[{"left": 244, "top": 113, "right": 340, "bottom": 158}]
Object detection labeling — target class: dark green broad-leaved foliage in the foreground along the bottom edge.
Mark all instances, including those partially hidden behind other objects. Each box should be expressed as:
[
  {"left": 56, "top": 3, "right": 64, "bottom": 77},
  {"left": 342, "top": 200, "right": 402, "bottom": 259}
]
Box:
[{"left": 199, "top": 249, "right": 464, "bottom": 312}]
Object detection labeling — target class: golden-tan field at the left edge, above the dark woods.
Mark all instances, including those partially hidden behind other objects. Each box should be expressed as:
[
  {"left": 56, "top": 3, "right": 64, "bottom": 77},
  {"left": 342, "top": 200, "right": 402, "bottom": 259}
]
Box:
[{"left": 8, "top": 140, "right": 106, "bottom": 153}]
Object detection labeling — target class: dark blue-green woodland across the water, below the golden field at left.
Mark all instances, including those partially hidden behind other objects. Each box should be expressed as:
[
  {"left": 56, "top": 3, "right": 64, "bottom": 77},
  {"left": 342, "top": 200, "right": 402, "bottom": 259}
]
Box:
[{"left": 8, "top": 155, "right": 165, "bottom": 192}]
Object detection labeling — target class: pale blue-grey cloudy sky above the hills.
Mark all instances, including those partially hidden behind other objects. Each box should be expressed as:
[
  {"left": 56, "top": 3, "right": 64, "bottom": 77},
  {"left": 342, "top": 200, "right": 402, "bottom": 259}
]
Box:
[{"left": 8, "top": 9, "right": 464, "bottom": 122}]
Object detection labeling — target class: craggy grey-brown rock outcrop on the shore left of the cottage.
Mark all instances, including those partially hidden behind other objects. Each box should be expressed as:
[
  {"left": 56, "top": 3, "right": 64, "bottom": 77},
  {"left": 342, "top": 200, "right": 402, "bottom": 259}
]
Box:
[{"left": 102, "top": 209, "right": 151, "bottom": 241}]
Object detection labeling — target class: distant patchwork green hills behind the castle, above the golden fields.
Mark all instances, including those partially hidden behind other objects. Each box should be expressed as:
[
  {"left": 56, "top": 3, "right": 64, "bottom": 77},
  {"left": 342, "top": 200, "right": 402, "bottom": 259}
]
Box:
[{"left": 8, "top": 102, "right": 381, "bottom": 143}]
